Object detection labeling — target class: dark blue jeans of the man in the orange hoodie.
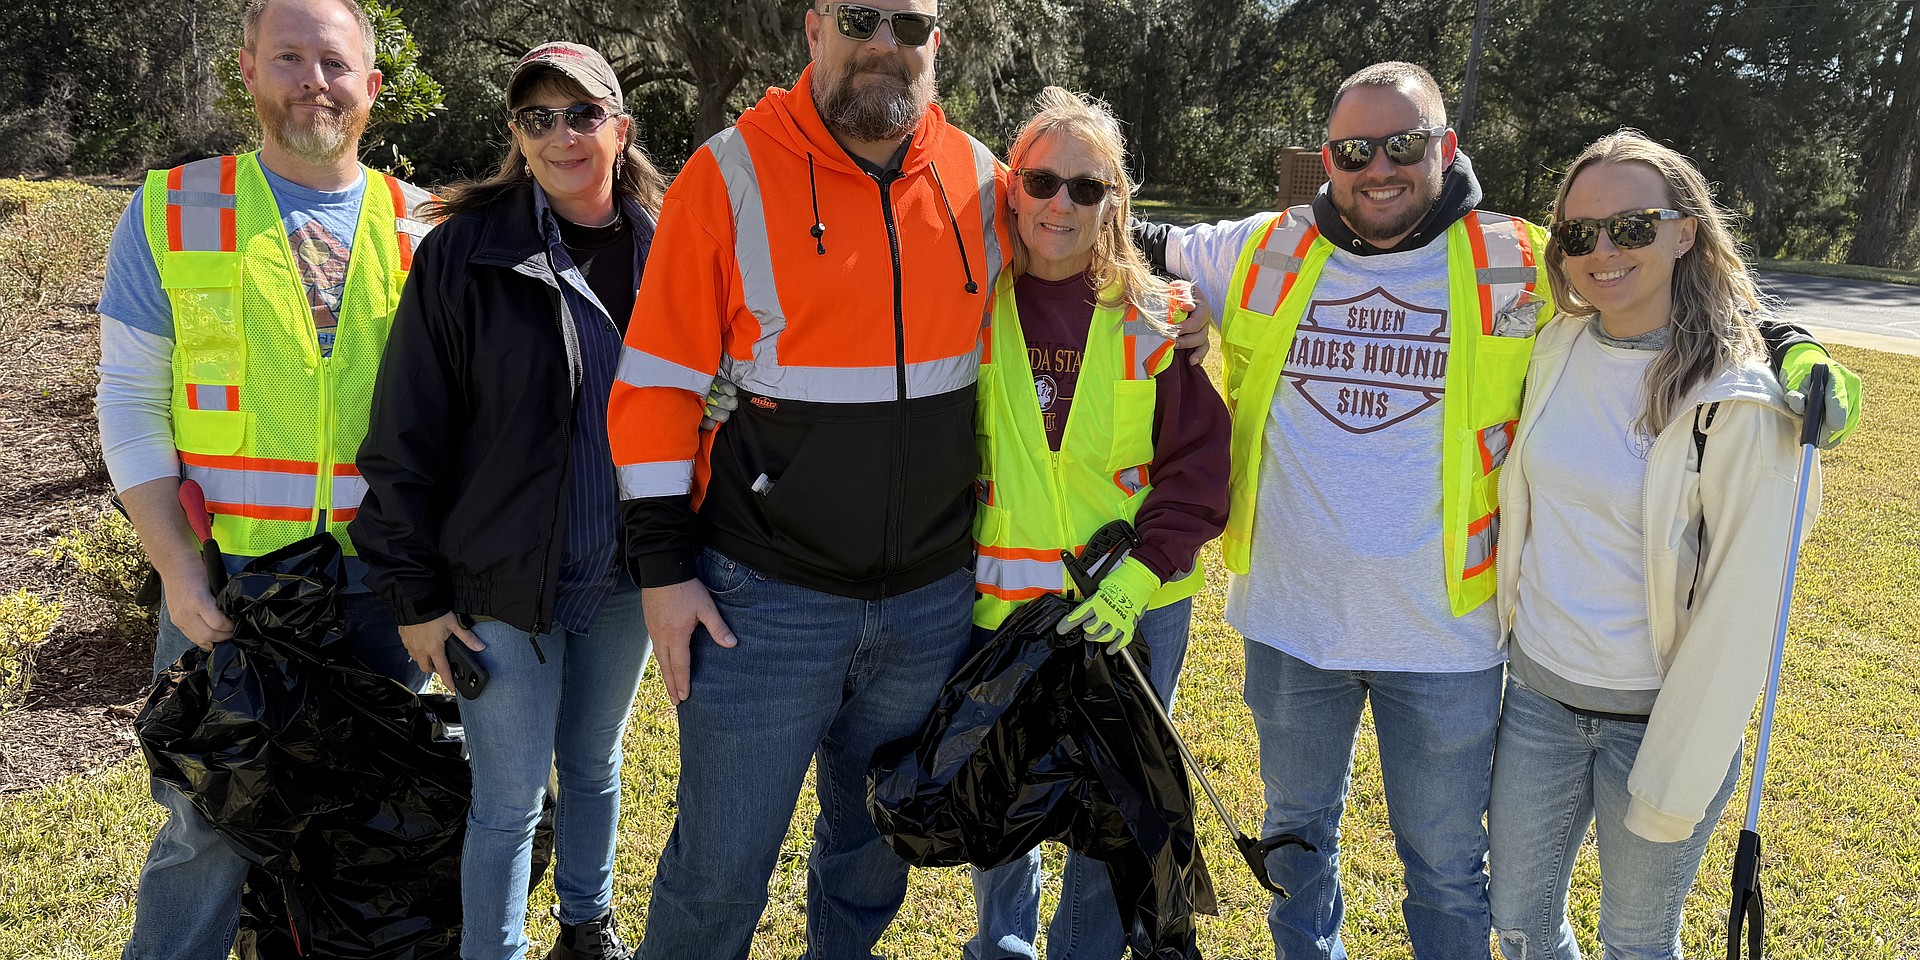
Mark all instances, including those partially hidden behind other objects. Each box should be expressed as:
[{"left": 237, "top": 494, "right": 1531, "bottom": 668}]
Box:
[{"left": 637, "top": 549, "right": 973, "bottom": 960}]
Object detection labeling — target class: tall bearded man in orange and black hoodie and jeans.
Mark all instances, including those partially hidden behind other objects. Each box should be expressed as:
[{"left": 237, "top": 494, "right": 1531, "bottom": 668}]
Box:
[{"left": 609, "top": 0, "right": 1008, "bottom": 960}]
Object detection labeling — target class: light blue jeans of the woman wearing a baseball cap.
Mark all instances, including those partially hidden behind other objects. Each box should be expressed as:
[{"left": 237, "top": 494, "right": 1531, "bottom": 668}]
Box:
[{"left": 461, "top": 574, "right": 653, "bottom": 960}]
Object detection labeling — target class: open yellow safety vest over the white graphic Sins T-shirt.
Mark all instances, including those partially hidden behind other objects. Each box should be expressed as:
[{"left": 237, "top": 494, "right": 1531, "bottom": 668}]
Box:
[{"left": 1221, "top": 205, "right": 1553, "bottom": 616}]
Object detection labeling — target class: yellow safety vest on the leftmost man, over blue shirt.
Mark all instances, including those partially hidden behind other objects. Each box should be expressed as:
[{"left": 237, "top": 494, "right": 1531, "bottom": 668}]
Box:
[{"left": 144, "top": 154, "right": 432, "bottom": 557}]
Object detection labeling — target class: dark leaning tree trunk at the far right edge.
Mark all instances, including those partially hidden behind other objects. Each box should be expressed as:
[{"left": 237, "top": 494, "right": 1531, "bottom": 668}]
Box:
[{"left": 1847, "top": 0, "right": 1920, "bottom": 267}]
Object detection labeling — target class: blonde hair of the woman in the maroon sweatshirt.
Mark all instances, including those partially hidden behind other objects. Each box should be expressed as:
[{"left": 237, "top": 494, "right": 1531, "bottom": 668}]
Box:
[{"left": 1008, "top": 86, "right": 1169, "bottom": 323}]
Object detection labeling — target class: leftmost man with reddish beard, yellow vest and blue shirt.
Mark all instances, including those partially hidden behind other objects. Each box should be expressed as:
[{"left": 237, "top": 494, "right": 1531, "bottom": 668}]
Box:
[{"left": 100, "top": 0, "right": 428, "bottom": 960}]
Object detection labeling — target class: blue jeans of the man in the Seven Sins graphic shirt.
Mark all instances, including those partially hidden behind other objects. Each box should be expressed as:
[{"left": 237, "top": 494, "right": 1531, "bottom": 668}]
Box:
[{"left": 1244, "top": 639, "right": 1505, "bottom": 960}]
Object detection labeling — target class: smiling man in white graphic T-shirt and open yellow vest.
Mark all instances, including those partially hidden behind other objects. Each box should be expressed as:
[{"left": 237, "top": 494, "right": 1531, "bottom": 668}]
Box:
[{"left": 1137, "top": 63, "right": 1850, "bottom": 960}]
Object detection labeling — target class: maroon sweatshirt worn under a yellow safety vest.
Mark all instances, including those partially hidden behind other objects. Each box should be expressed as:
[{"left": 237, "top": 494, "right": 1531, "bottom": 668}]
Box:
[{"left": 1014, "top": 275, "right": 1233, "bottom": 582}]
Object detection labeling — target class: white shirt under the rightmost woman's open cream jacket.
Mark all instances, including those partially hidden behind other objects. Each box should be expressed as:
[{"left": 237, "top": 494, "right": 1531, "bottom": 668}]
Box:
[{"left": 1513, "top": 324, "right": 1661, "bottom": 689}]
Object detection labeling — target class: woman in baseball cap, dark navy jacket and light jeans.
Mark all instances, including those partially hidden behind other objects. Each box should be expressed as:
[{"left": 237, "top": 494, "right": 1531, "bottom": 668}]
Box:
[{"left": 351, "top": 42, "right": 664, "bottom": 960}]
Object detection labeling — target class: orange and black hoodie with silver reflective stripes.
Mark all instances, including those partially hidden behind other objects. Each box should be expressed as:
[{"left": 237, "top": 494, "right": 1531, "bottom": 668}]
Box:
[{"left": 609, "top": 67, "right": 1008, "bottom": 599}]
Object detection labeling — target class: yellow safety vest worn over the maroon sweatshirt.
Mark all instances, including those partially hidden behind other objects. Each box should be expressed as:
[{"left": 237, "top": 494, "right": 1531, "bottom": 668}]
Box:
[{"left": 973, "top": 276, "right": 1206, "bottom": 630}]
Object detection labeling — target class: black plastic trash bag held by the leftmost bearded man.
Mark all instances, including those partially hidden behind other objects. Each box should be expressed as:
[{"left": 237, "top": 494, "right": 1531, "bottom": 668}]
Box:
[{"left": 134, "top": 534, "right": 472, "bottom": 960}]
